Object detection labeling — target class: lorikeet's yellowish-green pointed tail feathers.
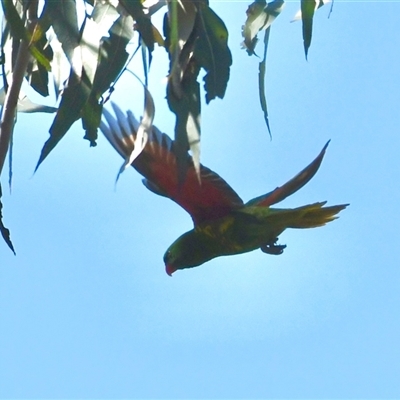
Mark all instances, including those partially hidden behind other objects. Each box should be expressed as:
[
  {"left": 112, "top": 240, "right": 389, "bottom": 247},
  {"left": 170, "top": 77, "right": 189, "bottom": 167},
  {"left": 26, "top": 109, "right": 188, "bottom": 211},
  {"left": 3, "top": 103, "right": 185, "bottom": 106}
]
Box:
[{"left": 285, "top": 201, "right": 348, "bottom": 229}]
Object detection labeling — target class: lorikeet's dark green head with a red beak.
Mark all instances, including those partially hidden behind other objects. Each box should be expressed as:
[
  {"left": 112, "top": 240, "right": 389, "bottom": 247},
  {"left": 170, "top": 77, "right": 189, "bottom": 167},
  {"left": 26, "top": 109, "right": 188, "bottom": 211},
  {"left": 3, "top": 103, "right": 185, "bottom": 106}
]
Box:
[{"left": 164, "top": 230, "right": 214, "bottom": 276}]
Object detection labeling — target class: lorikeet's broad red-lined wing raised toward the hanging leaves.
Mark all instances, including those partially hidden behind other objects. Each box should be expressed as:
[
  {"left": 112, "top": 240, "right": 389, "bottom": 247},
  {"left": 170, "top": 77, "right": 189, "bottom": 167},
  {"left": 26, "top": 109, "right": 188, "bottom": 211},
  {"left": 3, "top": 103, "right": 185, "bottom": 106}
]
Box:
[{"left": 100, "top": 104, "right": 243, "bottom": 225}]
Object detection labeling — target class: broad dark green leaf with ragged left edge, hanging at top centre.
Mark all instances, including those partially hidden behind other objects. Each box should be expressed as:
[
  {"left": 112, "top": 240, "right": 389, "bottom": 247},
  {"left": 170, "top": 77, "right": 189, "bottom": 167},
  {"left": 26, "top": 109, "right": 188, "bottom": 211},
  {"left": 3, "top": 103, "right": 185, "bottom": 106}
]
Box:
[{"left": 194, "top": 4, "right": 232, "bottom": 104}]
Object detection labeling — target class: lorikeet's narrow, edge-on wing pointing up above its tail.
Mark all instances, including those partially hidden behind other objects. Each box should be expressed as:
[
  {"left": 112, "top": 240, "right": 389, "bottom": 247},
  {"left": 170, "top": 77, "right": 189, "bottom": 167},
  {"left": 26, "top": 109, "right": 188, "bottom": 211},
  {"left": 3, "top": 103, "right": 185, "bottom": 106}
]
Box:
[{"left": 246, "top": 141, "right": 330, "bottom": 207}]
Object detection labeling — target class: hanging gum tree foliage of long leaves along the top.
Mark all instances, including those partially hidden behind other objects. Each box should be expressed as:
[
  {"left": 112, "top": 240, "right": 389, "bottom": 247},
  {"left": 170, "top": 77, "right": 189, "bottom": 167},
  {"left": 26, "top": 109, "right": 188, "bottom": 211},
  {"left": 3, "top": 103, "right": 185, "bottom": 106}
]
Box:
[{"left": 0, "top": 0, "right": 332, "bottom": 252}]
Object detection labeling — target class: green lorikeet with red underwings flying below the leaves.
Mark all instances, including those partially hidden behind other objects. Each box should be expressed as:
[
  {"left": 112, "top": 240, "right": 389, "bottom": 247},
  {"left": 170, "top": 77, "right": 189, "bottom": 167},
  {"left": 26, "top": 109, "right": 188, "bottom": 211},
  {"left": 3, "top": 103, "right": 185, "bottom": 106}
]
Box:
[{"left": 100, "top": 104, "right": 348, "bottom": 275}]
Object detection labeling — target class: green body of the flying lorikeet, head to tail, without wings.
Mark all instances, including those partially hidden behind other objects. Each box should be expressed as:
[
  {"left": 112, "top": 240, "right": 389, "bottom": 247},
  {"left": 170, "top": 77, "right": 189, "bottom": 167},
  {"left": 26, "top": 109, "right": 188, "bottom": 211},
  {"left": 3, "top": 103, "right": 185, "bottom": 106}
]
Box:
[{"left": 164, "top": 202, "right": 345, "bottom": 273}]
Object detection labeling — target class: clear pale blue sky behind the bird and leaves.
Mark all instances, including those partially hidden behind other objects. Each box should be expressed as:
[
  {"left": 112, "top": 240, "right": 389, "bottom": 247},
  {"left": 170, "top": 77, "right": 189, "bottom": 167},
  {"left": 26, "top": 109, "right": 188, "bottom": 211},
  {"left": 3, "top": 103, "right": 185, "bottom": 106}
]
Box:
[{"left": 0, "top": 1, "right": 400, "bottom": 398}]
